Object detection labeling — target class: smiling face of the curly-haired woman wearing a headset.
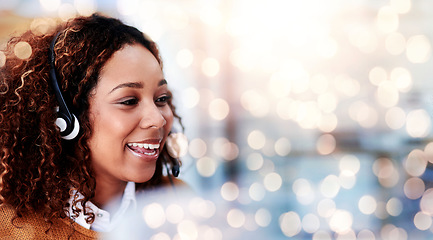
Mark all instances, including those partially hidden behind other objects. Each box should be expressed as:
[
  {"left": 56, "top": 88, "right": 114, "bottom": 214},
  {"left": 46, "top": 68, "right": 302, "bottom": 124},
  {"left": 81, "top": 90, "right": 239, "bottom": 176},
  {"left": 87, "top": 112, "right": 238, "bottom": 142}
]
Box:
[{"left": 88, "top": 44, "right": 173, "bottom": 184}]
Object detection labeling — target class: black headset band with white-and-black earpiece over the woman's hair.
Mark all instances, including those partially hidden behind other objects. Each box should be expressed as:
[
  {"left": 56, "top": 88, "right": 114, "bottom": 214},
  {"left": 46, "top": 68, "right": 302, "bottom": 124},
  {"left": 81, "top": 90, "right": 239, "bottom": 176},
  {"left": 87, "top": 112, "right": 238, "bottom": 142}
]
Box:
[{"left": 49, "top": 32, "right": 80, "bottom": 140}]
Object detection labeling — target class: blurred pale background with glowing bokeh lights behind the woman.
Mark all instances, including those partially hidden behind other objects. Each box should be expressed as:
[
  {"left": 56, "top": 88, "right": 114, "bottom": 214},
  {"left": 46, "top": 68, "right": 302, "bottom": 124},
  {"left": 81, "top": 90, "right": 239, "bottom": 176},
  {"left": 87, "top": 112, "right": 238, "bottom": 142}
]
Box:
[{"left": 0, "top": 0, "right": 433, "bottom": 240}]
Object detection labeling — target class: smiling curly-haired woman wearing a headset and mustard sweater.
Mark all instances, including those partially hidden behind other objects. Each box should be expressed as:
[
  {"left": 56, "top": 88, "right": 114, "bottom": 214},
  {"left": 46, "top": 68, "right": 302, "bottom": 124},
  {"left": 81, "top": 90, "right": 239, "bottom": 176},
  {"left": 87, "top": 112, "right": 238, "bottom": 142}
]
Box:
[{"left": 0, "top": 14, "right": 180, "bottom": 239}]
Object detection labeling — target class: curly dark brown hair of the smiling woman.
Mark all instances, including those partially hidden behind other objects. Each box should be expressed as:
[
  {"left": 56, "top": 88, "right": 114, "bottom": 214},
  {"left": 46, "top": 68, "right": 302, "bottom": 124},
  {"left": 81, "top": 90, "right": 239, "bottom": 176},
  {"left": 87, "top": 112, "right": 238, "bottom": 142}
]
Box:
[{"left": 0, "top": 14, "right": 180, "bottom": 222}]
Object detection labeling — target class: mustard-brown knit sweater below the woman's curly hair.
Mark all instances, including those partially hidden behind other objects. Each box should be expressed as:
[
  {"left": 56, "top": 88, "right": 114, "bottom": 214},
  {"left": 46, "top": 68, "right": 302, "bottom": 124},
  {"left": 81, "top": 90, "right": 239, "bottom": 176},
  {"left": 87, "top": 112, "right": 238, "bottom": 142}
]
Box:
[{"left": 0, "top": 205, "right": 98, "bottom": 240}]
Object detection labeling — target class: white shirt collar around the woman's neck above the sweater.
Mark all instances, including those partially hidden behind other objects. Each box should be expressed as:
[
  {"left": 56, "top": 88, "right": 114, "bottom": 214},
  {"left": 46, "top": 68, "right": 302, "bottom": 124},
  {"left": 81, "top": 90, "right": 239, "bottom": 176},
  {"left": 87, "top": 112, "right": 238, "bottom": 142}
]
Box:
[{"left": 69, "top": 182, "right": 137, "bottom": 232}]
